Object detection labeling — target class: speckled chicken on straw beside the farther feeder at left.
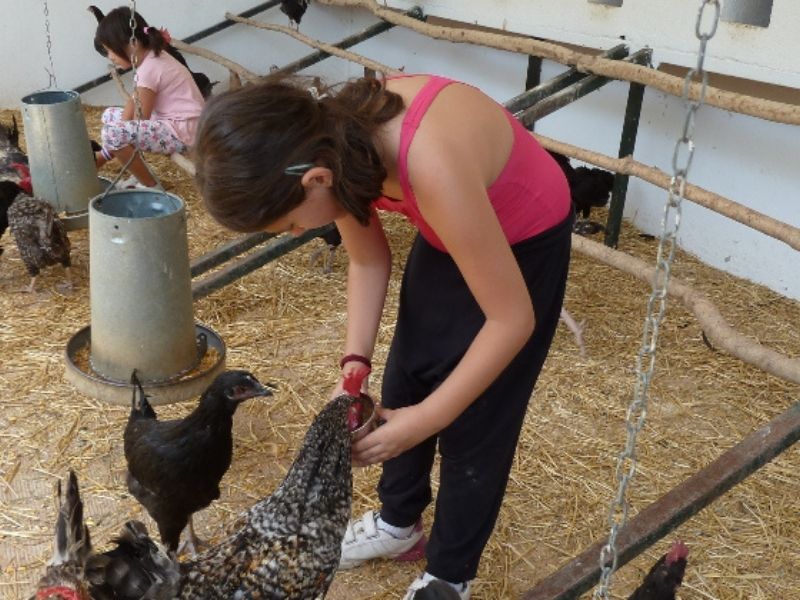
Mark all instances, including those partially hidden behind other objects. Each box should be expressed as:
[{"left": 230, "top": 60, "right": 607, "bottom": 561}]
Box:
[{"left": 7, "top": 166, "right": 72, "bottom": 292}]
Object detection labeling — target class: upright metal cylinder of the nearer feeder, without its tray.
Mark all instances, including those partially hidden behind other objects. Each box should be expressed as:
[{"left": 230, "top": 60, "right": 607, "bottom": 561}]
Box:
[{"left": 89, "top": 189, "right": 202, "bottom": 383}]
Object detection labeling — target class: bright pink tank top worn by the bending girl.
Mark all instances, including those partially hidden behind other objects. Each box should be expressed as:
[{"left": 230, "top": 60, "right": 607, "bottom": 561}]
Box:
[{"left": 375, "top": 75, "right": 571, "bottom": 252}]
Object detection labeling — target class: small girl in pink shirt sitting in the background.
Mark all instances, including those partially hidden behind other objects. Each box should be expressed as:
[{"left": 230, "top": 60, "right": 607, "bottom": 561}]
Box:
[{"left": 95, "top": 6, "right": 204, "bottom": 187}]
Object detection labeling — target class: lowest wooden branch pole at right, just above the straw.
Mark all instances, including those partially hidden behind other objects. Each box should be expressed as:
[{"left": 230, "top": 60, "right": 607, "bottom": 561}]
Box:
[{"left": 572, "top": 235, "right": 800, "bottom": 383}]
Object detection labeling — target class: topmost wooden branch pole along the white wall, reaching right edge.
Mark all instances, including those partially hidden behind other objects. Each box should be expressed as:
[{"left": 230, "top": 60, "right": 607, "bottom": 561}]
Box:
[{"left": 316, "top": 0, "right": 800, "bottom": 125}]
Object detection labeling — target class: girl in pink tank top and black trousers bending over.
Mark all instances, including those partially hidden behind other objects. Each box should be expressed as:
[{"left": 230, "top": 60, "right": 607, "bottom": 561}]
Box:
[{"left": 194, "top": 75, "right": 573, "bottom": 600}]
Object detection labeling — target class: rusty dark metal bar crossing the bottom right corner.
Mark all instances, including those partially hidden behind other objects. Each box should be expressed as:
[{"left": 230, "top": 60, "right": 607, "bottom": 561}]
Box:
[{"left": 522, "top": 402, "right": 800, "bottom": 600}]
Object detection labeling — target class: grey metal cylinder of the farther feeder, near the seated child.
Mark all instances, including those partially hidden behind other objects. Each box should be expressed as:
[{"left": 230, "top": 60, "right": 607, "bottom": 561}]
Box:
[{"left": 22, "top": 90, "right": 103, "bottom": 219}]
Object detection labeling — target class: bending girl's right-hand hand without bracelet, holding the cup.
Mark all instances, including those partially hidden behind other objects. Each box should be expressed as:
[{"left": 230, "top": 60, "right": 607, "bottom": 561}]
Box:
[{"left": 353, "top": 405, "right": 436, "bottom": 467}]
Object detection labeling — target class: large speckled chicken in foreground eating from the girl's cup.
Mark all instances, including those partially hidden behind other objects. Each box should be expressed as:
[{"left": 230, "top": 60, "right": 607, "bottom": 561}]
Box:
[{"left": 180, "top": 394, "right": 352, "bottom": 600}]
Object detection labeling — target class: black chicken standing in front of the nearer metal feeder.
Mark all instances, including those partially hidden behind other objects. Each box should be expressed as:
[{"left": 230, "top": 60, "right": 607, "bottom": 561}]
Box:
[{"left": 124, "top": 371, "right": 272, "bottom": 553}]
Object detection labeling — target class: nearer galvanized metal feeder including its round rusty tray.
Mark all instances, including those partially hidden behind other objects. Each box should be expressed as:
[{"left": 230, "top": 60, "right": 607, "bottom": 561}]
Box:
[{"left": 66, "top": 189, "right": 225, "bottom": 405}]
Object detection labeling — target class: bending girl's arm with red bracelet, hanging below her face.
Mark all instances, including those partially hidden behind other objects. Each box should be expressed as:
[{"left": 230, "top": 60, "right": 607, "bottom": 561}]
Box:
[{"left": 336, "top": 210, "right": 392, "bottom": 386}]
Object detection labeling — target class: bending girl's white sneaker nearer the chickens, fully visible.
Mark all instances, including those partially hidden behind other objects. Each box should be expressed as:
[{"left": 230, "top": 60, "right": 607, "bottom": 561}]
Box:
[{"left": 339, "top": 510, "right": 425, "bottom": 569}]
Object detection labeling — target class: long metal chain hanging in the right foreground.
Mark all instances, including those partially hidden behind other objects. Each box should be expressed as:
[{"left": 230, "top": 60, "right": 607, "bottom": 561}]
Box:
[{"left": 593, "top": 0, "right": 720, "bottom": 600}]
